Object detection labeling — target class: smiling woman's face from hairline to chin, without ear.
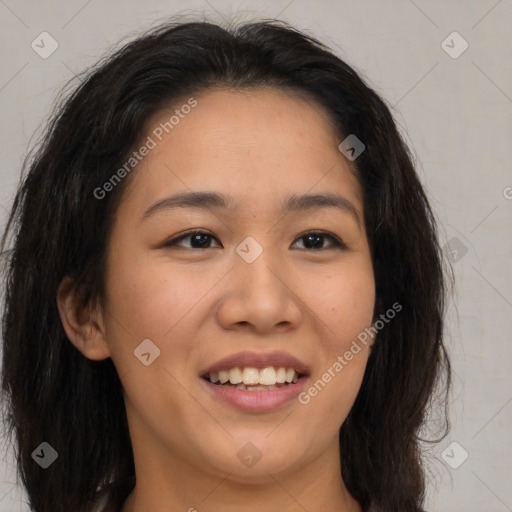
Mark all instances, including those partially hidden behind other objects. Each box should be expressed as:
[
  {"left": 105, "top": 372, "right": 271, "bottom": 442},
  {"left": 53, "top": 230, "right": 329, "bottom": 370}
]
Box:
[{"left": 89, "top": 89, "right": 375, "bottom": 492}]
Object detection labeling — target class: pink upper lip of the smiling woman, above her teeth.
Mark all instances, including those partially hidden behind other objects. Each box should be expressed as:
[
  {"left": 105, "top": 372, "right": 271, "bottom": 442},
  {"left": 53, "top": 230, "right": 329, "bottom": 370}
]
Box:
[{"left": 200, "top": 351, "right": 310, "bottom": 377}]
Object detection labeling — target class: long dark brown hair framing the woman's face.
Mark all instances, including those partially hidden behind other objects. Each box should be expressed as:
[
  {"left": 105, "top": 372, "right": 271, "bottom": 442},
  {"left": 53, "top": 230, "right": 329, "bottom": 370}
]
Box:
[{"left": 1, "top": 15, "right": 451, "bottom": 512}]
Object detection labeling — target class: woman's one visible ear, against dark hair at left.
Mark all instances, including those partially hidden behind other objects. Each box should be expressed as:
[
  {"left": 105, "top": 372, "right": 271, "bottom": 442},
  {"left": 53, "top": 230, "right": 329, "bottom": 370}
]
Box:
[{"left": 57, "top": 276, "right": 110, "bottom": 361}]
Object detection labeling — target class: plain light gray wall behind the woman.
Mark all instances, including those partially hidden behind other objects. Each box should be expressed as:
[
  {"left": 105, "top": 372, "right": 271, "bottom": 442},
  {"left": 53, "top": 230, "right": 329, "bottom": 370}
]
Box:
[{"left": 0, "top": 0, "right": 512, "bottom": 512}]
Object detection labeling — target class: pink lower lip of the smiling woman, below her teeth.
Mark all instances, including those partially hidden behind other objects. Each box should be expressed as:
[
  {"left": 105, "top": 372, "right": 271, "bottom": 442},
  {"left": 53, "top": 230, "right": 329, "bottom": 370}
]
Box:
[{"left": 201, "top": 376, "right": 308, "bottom": 412}]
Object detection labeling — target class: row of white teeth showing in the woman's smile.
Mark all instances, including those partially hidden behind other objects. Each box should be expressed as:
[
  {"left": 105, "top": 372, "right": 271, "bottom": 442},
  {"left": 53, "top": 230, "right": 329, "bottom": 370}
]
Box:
[{"left": 209, "top": 366, "right": 299, "bottom": 391}]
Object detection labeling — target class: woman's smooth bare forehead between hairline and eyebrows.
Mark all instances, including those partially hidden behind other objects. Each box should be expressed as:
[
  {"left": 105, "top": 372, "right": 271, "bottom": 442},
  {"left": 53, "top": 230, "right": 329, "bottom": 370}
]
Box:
[{"left": 121, "top": 88, "right": 362, "bottom": 214}]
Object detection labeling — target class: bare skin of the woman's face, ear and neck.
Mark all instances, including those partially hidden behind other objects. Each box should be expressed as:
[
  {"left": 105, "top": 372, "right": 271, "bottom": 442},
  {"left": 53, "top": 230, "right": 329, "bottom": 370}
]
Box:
[{"left": 58, "top": 89, "right": 375, "bottom": 512}]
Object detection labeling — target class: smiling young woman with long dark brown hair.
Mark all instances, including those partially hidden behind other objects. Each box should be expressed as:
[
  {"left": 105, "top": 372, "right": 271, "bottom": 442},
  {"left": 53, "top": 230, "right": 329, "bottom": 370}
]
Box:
[{"left": 2, "top": 16, "right": 450, "bottom": 512}]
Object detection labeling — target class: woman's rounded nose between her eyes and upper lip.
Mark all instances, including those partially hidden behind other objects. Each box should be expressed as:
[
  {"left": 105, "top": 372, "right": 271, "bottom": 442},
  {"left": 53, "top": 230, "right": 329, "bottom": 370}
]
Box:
[{"left": 217, "top": 251, "right": 303, "bottom": 334}]
